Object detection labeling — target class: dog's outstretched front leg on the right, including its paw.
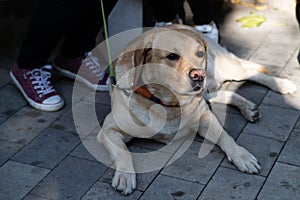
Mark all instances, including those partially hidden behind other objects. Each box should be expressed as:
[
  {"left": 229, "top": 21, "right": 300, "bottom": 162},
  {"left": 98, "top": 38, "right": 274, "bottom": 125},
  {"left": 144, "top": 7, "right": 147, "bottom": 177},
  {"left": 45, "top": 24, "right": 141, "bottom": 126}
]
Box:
[{"left": 198, "top": 111, "right": 260, "bottom": 174}]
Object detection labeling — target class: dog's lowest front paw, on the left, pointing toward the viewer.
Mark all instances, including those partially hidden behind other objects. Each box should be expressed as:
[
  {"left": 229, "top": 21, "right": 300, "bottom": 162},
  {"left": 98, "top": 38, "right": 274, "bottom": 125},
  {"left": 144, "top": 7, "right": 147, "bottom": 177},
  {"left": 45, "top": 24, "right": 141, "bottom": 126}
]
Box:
[{"left": 112, "top": 170, "right": 136, "bottom": 195}]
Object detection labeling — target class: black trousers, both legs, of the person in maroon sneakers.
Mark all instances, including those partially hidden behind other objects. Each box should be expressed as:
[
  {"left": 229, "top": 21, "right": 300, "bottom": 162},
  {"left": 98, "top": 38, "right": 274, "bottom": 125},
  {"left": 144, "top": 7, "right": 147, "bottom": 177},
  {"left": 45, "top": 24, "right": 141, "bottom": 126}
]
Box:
[{"left": 17, "top": 0, "right": 117, "bottom": 69}]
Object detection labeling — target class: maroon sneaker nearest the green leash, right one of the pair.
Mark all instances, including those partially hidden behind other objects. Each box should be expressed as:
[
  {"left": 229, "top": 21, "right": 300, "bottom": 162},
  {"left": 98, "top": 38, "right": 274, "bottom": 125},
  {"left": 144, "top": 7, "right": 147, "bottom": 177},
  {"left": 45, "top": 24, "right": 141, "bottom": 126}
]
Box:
[{"left": 54, "top": 53, "right": 109, "bottom": 91}]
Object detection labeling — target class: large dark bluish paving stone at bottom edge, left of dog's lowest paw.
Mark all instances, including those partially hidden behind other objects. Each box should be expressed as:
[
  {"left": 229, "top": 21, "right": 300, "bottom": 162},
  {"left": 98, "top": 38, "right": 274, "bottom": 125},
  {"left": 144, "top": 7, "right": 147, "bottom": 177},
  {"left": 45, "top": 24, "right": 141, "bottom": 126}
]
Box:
[{"left": 31, "top": 157, "right": 106, "bottom": 199}]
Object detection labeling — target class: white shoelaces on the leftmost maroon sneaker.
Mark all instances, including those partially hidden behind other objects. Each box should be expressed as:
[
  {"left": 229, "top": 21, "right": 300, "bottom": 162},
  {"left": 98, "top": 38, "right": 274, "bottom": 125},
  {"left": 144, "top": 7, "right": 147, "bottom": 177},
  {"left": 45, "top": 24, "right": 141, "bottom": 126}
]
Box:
[{"left": 27, "top": 65, "right": 55, "bottom": 98}]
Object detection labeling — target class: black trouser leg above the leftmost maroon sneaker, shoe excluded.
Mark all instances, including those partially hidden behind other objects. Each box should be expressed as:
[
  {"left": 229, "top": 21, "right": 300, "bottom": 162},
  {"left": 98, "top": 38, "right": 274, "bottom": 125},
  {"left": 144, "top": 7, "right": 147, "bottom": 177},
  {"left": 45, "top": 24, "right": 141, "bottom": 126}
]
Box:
[{"left": 17, "top": 0, "right": 72, "bottom": 69}]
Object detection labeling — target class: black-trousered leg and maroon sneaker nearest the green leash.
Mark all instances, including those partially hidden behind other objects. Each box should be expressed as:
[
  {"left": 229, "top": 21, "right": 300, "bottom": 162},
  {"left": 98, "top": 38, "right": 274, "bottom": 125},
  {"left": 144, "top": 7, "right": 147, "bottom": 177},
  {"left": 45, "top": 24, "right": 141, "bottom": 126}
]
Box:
[{"left": 54, "top": 0, "right": 121, "bottom": 91}]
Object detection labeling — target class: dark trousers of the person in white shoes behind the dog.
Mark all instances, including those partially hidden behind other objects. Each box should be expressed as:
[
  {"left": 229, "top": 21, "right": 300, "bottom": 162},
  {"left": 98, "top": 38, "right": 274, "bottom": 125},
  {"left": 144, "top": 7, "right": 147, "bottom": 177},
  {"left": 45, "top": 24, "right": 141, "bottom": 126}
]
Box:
[{"left": 149, "top": 0, "right": 214, "bottom": 25}]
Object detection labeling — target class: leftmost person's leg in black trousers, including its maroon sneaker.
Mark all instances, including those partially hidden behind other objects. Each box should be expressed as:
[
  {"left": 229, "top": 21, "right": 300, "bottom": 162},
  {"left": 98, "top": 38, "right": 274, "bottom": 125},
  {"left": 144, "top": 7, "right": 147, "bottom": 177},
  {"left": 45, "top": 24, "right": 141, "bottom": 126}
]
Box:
[{"left": 10, "top": 0, "right": 84, "bottom": 111}]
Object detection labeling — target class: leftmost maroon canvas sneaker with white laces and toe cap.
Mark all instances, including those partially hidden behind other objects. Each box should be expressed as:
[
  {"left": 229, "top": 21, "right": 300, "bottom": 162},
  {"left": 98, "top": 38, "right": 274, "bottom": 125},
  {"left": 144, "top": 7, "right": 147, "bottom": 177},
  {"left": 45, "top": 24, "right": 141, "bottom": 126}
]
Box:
[{"left": 10, "top": 64, "right": 64, "bottom": 111}]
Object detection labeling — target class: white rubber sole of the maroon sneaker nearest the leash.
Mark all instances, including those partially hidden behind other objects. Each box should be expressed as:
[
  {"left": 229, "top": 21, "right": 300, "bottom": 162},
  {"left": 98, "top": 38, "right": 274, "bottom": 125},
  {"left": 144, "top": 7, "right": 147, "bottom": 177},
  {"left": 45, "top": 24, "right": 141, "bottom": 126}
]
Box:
[{"left": 53, "top": 64, "right": 109, "bottom": 92}]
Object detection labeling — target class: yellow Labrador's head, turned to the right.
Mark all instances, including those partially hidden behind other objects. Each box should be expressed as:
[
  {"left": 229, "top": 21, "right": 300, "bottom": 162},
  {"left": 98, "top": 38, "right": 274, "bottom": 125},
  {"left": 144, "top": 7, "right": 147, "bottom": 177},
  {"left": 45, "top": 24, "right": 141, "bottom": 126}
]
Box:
[{"left": 115, "top": 26, "right": 207, "bottom": 103}]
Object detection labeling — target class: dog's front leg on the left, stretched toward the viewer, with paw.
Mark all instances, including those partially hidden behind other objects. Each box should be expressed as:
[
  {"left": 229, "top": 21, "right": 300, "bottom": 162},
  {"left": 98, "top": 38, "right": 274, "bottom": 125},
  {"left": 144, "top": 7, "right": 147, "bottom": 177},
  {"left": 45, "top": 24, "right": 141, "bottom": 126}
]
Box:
[{"left": 97, "top": 116, "right": 136, "bottom": 195}]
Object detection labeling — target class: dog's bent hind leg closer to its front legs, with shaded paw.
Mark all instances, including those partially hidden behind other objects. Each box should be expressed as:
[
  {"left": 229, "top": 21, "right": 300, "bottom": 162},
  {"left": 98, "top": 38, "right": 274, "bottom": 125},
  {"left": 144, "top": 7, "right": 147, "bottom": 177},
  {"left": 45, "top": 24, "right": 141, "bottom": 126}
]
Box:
[{"left": 204, "top": 90, "right": 260, "bottom": 122}]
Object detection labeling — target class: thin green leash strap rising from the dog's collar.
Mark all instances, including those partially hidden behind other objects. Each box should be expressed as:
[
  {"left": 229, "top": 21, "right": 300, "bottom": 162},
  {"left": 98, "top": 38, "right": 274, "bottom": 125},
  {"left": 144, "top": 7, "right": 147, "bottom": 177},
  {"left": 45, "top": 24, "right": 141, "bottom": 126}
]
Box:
[{"left": 100, "top": 0, "right": 116, "bottom": 85}]
